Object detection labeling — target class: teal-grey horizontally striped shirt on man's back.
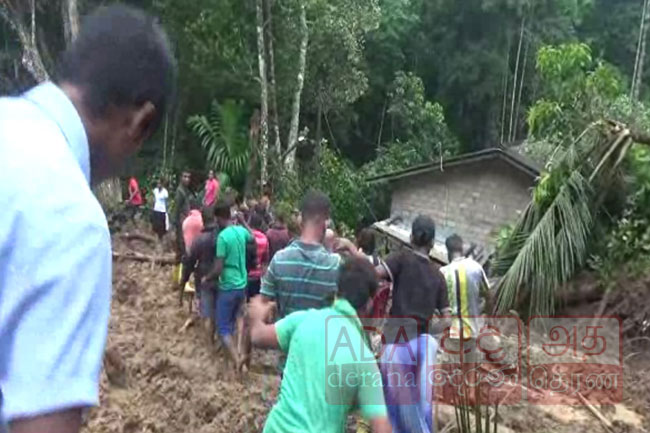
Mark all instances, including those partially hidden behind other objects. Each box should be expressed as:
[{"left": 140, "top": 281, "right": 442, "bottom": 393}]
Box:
[{"left": 260, "top": 240, "right": 341, "bottom": 318}]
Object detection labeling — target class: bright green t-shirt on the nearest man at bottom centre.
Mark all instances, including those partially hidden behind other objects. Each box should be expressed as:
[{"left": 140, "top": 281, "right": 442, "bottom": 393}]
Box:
[{"left": 264, "top": 299, "right": 386, "bottom": 433}]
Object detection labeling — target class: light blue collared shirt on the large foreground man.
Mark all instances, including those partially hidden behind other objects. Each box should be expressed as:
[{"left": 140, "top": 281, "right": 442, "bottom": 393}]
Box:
[{"left": 0, "top": 83, "right": 111, "bottom": 424}]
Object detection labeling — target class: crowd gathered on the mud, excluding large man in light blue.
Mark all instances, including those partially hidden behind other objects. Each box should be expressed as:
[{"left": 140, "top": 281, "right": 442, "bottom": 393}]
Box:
[{"left": 157, "top": 172, "right": 487, "bottom": 432}]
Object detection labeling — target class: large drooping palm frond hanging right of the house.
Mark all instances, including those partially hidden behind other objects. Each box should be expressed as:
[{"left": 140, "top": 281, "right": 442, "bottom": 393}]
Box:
[{"left": 494, "top": 122, "right": 632, "bottom": 314}]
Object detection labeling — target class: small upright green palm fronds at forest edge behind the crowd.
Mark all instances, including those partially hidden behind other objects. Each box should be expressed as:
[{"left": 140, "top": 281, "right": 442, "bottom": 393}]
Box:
[{"left": 187, "top": 99, "right": 251, "bottom": 177}]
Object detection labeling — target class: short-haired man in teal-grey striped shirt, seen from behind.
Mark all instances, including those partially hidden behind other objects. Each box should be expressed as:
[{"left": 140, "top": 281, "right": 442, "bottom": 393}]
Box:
[{"left": 260, "top": 191, "right": 342, "bottom": 318}]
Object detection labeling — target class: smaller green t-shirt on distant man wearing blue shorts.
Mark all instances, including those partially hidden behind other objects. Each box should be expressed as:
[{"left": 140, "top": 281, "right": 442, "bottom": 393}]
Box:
[{"left": 217, "top": 225, "right": 252, "bottom": 290}]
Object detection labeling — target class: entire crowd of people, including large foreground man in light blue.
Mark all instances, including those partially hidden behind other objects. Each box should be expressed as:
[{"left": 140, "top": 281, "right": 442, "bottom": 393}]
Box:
[{"left": 0, "top": 4, "right": 487, "bottom": 433}]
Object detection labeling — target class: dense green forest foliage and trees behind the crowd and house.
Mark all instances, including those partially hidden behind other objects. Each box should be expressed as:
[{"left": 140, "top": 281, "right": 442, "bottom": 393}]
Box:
[{"left": 0, "top": 0, "right": 650, "bottom": 300}]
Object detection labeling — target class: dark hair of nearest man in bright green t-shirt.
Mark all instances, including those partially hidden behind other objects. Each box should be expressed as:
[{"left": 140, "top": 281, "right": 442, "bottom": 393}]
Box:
[{"left": 337, "top": 257, "right": 378, "bottom": 310}]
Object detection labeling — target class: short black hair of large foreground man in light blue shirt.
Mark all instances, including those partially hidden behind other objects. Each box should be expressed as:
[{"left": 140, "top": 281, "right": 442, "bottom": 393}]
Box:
[{"left": 57, "top": 5, "right": 176, "bottom": 131}]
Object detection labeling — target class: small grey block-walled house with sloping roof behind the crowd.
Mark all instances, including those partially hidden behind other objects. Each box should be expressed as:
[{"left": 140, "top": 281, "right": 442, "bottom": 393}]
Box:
[{"left": 369, "top": 147, "right": 539, "bottom": 255}]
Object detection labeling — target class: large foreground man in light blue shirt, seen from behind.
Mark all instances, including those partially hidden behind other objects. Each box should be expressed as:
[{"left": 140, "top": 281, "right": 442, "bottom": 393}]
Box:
[{"left": 0, "top": 5, "right": 176, "bottom": 433}]
